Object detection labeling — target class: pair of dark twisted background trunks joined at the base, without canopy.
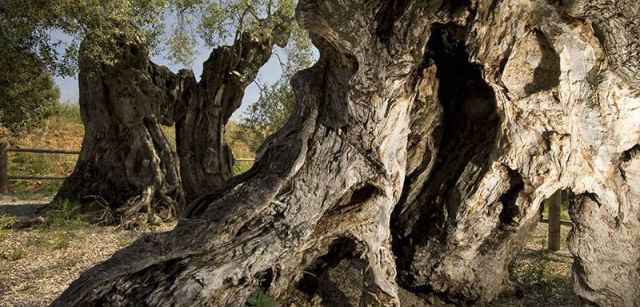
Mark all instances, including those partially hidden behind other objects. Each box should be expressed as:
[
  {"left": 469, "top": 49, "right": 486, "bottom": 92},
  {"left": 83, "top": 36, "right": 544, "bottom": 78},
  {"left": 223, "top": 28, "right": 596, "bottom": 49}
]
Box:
[{"left": 56, "top": 1, "right": 304, "bottom": 226}]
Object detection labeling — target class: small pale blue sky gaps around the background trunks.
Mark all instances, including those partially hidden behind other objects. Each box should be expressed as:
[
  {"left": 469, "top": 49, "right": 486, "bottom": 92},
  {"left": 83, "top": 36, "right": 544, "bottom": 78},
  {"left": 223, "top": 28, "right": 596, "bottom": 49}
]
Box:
[{"left": 54, "top": 45, "right": 282, "bottom": 120}]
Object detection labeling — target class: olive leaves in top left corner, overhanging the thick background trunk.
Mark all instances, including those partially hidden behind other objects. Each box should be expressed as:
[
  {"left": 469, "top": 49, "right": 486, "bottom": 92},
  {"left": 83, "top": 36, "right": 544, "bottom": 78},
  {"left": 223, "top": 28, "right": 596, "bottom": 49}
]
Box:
[{"left": 0, "top": 0, "right": 167, "bottom": 75}]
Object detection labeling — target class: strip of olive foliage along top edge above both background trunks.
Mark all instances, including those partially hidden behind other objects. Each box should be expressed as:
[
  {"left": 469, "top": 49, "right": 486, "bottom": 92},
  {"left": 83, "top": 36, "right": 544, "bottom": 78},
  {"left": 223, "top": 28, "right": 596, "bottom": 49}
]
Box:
[{"left": 0, "top": 0, "right": 302, "bottom": 71}]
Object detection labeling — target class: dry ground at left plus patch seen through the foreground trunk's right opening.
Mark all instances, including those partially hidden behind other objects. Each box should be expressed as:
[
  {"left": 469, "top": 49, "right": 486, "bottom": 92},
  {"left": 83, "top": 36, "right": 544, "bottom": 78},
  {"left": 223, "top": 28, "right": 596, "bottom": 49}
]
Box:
[{"left": 0, "top": 200, "right": 580, "bottom": 307}]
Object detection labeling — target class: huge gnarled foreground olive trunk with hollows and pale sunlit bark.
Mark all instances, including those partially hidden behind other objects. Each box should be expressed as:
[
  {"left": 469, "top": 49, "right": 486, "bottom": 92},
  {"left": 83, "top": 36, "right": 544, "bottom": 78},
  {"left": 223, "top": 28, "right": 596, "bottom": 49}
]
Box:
[{"left": 53, "top": 0, "right": 640, "bottom": 306}]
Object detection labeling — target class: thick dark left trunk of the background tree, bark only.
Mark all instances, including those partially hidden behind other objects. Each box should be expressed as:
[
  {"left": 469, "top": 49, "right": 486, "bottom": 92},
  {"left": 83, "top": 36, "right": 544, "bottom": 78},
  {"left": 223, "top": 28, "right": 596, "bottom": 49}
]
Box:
[{"left": 56, "top": 40, "right": 184, "bottom": 226}]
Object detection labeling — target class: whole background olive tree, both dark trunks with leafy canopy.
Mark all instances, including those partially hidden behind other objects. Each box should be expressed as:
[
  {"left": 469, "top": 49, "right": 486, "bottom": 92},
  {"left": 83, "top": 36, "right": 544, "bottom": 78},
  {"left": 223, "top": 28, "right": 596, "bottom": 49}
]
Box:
[{"left": 3, "top": 0, "right": 318, "bottom": 224}]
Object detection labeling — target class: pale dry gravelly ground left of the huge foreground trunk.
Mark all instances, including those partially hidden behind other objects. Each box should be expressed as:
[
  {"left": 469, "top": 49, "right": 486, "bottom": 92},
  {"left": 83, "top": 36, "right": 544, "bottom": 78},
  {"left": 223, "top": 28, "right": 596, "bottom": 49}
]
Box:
[{"left": 0, "top": 200, "right": 171, "bottom": 307}]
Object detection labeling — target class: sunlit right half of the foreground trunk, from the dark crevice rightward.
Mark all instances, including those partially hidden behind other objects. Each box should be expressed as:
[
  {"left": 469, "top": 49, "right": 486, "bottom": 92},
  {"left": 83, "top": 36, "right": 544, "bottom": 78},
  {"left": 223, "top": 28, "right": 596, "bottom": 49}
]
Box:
[{"left": 394, "top": 1, "right": 640, "bottom": 306}]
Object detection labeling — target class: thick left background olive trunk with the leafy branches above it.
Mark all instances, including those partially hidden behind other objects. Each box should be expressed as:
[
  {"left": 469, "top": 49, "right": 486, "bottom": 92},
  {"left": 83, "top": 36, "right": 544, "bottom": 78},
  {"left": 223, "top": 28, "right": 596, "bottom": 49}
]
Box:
[{"left": 5, "top": 0, "right": 182, "bottom": 226}]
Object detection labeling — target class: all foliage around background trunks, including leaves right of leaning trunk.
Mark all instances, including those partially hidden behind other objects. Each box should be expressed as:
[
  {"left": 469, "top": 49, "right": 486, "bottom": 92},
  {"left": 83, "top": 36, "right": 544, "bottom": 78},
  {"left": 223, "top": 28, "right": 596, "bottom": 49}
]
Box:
[{"left": 0, "top": 0, "right": 312, "bottom": 140}]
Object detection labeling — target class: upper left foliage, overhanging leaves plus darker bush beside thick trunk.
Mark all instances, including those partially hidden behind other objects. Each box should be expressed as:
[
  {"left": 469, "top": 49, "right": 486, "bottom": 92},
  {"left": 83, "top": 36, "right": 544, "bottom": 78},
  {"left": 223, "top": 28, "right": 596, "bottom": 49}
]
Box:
[{"left": 0, "top": 0, "right": 154, "bottom": 134}]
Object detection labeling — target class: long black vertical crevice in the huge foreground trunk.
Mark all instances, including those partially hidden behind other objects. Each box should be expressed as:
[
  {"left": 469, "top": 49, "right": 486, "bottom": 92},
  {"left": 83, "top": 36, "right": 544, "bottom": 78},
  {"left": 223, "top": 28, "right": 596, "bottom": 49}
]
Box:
[{"left": 392, "top": 25, "right": 500, "bottom": 294}]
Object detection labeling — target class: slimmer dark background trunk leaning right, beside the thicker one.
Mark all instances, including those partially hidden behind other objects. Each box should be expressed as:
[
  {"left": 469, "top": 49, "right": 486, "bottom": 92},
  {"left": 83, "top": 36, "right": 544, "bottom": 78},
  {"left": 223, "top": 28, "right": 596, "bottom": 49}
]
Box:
[{"left": 176, "top": 25, "right": 288, "bottom": 202}]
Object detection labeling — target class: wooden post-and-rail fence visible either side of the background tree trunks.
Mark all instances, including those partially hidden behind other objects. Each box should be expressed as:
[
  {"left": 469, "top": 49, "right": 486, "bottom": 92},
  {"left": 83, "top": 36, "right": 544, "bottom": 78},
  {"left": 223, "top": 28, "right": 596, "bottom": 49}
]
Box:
[{"left": 0, "top": 143, "right": 255, "bottom": 195}]
